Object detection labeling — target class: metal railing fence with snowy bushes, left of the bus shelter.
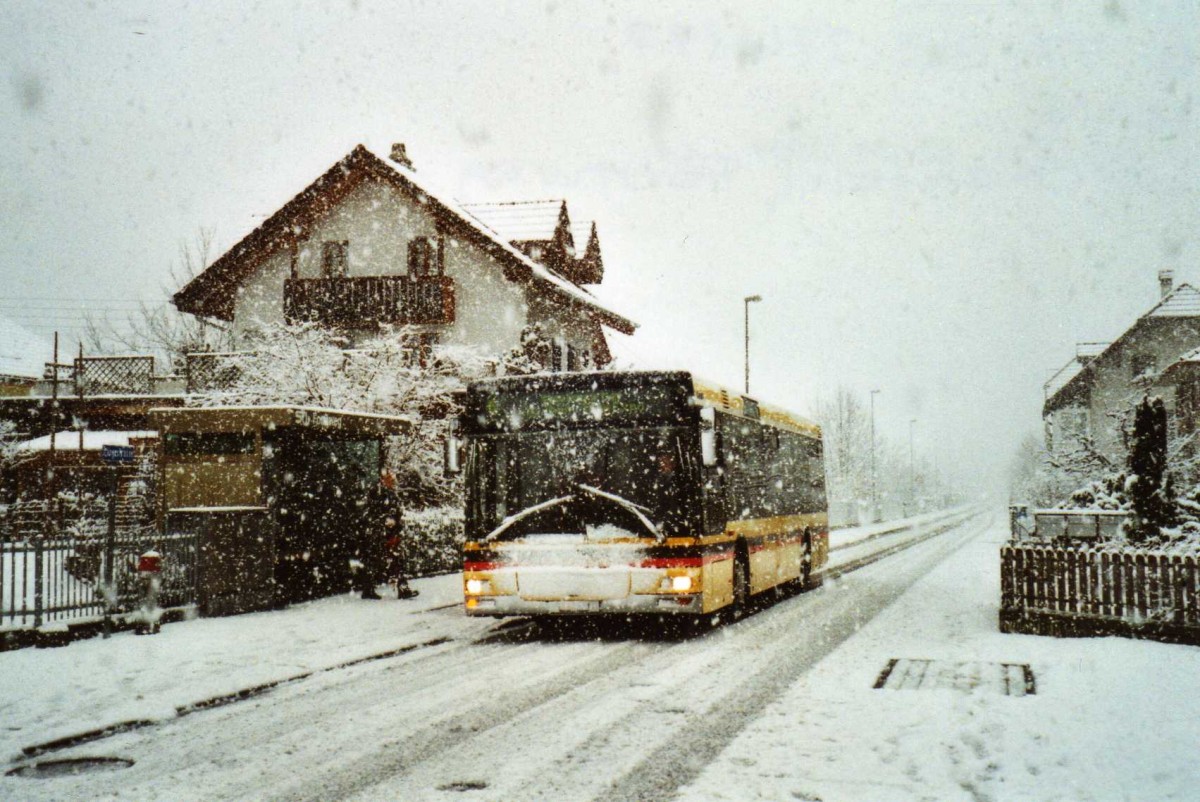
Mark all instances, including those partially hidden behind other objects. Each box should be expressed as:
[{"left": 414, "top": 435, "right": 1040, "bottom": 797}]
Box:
[{"left": 0, "top": 505, "right": 198, "bottom": 629}]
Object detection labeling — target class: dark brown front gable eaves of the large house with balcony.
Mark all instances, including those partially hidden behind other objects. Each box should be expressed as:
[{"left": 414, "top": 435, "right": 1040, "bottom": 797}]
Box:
[{"left": 172, "top": 145, "right": 637, "bottom": 334}]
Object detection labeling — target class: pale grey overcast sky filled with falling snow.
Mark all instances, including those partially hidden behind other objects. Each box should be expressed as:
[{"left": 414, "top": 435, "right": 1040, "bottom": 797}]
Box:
[{"left": 0, "top": 0, "right": 1200, "bottom": 492}]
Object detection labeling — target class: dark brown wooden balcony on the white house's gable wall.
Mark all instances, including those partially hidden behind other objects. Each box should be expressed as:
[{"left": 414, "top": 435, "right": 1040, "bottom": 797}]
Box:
[{"left": 283, "top": 276, "right": 454, "bottom": 329}]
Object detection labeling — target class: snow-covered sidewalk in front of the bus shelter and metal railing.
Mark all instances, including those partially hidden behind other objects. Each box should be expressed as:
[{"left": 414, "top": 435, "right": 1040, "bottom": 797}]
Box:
[{"left": 0, "top": 574, "right": 491, "bottom": 759}]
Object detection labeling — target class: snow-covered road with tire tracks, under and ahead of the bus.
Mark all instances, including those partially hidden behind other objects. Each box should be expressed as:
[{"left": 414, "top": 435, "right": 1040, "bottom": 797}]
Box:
[{"left": 0, "top": 511, "right": 980, "bottom": 801}]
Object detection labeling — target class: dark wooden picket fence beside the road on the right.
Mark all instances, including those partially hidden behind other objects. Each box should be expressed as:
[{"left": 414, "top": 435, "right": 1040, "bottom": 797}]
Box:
[{"left": 1000, "top": 544, "right": 1200, "bottom": 645}]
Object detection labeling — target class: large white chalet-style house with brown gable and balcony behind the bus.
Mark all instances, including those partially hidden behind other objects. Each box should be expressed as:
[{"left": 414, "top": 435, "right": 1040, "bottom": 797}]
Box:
[{"left": 173, "top": 144, "right": 636, "bottom": 370}]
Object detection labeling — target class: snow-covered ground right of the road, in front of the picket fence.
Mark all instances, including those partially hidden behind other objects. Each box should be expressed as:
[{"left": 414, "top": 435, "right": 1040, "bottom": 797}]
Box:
[{"left": 677, "top": 513, "right": 1200, "bottom": 802}]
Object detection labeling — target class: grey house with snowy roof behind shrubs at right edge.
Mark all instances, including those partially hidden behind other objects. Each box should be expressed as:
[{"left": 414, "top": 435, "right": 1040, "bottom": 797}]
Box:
[{"left": 1042, "top": 270, "right": 1200, "bottom": 466}]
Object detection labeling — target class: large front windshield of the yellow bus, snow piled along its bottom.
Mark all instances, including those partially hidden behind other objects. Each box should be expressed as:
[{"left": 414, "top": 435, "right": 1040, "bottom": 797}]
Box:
[{"left": 467, "top": 426, "right": 698, "bottom": 537}]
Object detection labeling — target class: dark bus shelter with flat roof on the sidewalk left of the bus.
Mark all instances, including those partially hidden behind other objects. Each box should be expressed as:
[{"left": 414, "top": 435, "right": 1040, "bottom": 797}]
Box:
[{"left": 150, "top": 407, "right": 412, "bottom": 615}]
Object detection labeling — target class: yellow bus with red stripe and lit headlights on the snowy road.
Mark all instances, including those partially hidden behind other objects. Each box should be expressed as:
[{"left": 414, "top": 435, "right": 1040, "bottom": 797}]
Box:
[{"left": 446, "top": 371, "right": 829, "bottom": 618}]
